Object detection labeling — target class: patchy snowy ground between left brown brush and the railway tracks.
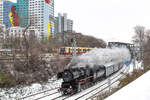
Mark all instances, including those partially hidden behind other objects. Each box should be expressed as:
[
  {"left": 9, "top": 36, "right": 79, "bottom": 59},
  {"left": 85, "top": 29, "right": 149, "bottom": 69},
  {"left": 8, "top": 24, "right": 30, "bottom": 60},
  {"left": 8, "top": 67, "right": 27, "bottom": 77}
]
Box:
[{"left": 0, "top": 77, "right": 62, "bottom": 100}]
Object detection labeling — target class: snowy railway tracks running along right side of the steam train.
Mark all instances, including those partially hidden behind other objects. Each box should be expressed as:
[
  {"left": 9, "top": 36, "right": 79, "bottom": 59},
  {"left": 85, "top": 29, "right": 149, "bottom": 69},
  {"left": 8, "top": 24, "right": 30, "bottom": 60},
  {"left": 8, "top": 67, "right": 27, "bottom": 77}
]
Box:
[{"left": 49, "top": 67, "right": 128, "bottom": 100}]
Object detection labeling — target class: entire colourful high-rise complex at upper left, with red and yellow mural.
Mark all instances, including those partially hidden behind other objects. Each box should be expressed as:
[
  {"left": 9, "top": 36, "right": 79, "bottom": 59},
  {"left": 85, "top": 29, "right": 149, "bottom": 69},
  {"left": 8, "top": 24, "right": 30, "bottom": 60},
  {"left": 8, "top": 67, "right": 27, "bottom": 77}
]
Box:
[{"left": 0, "top": 0, "right": 54, "bottom": 40}]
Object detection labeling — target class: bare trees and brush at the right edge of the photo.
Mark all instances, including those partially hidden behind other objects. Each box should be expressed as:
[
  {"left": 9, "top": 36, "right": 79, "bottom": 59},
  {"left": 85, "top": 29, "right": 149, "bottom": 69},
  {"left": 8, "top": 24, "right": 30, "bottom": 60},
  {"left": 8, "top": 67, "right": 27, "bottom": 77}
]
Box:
[{"left": 133, "top": 26, "right": 150, "bottom": 67}]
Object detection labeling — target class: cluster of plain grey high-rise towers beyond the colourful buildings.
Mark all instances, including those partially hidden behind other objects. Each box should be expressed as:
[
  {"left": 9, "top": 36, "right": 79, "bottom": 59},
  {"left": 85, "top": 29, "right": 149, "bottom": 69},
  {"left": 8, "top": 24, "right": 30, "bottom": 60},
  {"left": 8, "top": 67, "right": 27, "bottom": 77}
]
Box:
[{"left": 55, "top": 13, "right": 73, "bottom": 33}]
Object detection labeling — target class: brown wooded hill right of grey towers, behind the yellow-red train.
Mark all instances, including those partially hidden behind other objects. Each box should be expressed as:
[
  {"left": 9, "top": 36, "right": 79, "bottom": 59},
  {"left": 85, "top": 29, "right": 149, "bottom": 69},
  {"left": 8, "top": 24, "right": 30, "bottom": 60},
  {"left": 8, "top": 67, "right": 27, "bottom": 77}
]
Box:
[{"left": 56, "top": 31, "right": 106, "bottom": 48}]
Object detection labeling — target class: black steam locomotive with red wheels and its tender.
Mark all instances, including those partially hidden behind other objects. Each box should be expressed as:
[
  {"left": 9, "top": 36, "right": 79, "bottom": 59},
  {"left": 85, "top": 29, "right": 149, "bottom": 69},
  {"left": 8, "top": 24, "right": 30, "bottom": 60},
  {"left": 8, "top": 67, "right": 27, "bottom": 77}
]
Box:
[{"left": 57, "top": 65, "right": 105, "bottom": 94}]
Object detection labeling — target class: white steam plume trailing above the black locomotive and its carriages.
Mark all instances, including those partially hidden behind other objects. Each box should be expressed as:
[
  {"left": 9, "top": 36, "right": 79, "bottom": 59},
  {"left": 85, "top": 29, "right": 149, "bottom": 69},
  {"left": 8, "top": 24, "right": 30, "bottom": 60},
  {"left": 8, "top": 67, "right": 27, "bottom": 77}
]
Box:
[{"left": 68, "top": 48, "right": 131, "bottom": 68}]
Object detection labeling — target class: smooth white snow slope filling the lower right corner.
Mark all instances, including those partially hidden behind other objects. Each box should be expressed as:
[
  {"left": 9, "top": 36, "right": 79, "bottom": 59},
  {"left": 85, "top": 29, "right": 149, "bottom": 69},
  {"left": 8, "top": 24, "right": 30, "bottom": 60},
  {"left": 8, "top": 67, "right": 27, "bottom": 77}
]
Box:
[{"left": 105, "top": 71, "right": 150, "bottom": 100}]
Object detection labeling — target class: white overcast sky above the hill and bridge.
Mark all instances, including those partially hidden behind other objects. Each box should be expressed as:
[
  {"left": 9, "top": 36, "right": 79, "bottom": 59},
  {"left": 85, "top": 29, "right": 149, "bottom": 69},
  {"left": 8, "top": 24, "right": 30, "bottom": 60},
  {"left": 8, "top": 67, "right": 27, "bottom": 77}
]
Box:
[{"left": 10, "top": 0, "right": 150, "bottom": 42}]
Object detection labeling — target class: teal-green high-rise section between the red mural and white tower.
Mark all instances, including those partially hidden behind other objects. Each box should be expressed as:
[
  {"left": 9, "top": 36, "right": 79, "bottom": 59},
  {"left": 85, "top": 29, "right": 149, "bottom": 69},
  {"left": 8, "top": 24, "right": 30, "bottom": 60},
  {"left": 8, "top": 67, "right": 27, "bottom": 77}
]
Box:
[{"left": 16, "top": 0, "right": 28, "bottom": 27}]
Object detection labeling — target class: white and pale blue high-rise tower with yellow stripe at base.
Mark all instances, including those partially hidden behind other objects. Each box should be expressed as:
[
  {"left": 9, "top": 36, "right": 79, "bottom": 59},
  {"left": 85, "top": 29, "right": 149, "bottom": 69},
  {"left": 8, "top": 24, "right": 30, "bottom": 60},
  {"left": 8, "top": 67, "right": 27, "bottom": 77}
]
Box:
[{"left": 29, "top": 0, "right": 54, "bottom": 40}]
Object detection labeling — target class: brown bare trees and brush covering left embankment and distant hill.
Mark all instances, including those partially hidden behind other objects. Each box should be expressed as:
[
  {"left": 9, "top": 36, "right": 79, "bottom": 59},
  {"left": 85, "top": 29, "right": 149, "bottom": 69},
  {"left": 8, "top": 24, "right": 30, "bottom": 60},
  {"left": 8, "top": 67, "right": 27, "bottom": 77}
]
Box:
[{"left": 0, "top": 27, "right": 106, "bottom": 88}]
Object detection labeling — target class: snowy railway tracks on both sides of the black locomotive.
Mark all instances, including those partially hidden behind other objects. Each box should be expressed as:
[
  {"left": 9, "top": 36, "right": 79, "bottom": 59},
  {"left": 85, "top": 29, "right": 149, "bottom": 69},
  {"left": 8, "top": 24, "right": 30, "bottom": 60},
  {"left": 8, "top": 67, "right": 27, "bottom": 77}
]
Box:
[{"left": 19, "top": 64, "right": 127, "bottom": 100}]
